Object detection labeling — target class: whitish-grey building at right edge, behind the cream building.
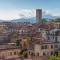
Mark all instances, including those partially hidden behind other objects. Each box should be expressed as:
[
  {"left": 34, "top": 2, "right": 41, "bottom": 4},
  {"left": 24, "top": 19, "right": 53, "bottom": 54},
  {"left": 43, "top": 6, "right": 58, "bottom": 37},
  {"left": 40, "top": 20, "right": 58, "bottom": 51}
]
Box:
[{"left": 47, "top": 29, "right": 60, "bottom": 42}]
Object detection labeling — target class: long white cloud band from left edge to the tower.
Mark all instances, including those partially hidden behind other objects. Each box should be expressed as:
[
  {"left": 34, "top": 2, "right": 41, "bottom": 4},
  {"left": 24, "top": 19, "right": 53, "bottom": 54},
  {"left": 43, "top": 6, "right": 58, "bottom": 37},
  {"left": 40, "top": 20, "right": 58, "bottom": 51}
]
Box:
[{"left": 0, "top": 9, "right": 35, "bottom": 20}]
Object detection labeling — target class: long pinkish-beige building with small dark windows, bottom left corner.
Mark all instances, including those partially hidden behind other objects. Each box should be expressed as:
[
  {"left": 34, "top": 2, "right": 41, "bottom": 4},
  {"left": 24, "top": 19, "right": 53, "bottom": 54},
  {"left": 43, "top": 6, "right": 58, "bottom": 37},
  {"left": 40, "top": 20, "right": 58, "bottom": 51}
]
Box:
[{"left": 0, "top": 48, "right": 20, "bottom": 59}]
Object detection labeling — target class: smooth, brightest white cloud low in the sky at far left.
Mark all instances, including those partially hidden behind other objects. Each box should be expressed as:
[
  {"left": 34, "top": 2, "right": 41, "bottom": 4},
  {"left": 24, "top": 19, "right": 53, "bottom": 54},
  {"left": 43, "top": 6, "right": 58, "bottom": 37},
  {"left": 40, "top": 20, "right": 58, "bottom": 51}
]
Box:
[{"left": 0, "top": 11, "right": 20, "bottom": 20}]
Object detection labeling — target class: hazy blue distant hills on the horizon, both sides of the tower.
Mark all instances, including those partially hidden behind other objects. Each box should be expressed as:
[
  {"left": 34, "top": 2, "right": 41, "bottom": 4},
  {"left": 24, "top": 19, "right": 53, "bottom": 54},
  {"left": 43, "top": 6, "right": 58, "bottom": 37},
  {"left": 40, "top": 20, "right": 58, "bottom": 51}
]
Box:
[{"left": 0, "top": 15, "right": 60, "bottom": 23}]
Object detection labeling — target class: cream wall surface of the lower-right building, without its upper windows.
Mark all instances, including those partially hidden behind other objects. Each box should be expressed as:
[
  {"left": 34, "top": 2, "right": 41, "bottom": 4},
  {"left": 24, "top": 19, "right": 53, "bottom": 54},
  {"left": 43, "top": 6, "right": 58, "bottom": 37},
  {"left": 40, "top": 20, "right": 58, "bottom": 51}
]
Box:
[{"left": 34, "top": 43, "right": 60, "bottom": 56}]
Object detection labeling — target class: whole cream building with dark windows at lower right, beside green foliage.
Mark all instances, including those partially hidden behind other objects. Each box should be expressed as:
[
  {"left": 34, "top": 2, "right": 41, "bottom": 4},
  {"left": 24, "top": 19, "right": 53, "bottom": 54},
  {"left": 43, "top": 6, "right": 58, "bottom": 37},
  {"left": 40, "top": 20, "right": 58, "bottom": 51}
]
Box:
[{"left": 34, "top": 42, "right": 60, "bottom": 56}]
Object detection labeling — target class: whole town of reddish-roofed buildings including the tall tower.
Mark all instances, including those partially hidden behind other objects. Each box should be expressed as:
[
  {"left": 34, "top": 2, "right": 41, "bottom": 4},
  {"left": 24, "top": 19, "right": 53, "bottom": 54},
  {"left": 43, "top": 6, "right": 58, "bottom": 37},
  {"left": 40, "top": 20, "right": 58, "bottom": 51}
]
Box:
[{"left": 0, "top": 9, "right": 60, "bottom": 60}]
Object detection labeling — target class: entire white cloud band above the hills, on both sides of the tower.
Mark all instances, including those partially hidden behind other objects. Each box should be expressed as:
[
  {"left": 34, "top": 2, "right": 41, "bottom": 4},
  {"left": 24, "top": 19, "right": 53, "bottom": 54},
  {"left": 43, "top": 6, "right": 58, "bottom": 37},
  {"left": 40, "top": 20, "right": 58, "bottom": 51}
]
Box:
[{"left": 0, "top": 9, "right": 60, "bottom": 20}]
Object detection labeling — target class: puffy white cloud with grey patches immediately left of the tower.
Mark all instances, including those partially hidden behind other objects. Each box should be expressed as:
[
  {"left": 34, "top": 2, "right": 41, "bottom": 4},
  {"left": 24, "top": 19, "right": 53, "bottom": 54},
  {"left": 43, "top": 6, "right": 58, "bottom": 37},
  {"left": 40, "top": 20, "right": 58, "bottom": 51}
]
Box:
[{"left": 19, "top": 9, "right": 36, "bottom": 18}]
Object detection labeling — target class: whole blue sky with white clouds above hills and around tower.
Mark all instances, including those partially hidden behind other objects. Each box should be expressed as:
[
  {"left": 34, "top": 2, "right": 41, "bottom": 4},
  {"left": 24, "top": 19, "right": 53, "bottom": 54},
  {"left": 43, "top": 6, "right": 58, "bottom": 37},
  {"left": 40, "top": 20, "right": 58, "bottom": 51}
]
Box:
[{"left": 0, "top": 0, "right": 60, "bottom": 20}]
